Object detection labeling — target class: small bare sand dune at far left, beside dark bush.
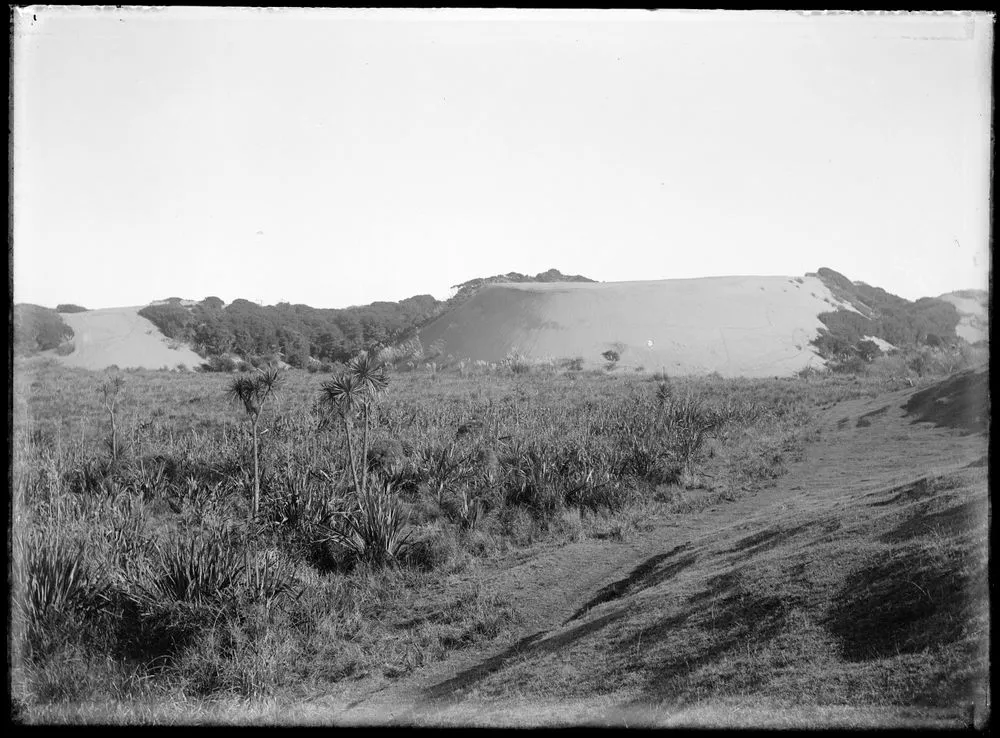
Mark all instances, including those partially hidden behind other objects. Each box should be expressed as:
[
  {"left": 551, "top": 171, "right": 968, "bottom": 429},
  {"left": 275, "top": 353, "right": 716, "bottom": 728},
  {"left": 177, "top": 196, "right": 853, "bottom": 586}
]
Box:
[{"left": 48, "top": 307, "right": 204, "bottom": 369}]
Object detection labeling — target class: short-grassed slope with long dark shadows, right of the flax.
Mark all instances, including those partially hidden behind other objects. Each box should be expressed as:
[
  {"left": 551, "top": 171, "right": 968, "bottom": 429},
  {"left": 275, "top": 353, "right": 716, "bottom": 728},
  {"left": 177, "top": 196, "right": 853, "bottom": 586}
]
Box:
[{"left": 331, "top": 372, "right": 989, "bottom": 727}]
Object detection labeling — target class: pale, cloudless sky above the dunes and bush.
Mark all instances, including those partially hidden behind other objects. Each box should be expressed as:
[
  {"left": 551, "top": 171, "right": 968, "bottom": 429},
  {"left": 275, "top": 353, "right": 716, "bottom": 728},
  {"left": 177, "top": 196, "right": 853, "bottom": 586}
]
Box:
[{"left": 11, "top": 6, "right": 994, "bottom": 309}]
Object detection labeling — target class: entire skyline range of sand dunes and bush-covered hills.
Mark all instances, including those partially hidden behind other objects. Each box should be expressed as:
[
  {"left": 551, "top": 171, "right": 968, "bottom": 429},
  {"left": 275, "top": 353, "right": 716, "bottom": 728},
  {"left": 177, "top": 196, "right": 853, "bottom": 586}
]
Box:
[{"left": 13, "top": 268, "right": 988, "bottom": 376}]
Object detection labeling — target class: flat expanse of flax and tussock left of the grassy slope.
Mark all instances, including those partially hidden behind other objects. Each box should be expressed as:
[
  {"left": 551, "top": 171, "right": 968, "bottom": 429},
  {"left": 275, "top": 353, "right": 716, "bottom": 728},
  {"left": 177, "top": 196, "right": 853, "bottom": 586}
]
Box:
[{"left": 12, "top": 357, "right": 948, "bottom": 714}]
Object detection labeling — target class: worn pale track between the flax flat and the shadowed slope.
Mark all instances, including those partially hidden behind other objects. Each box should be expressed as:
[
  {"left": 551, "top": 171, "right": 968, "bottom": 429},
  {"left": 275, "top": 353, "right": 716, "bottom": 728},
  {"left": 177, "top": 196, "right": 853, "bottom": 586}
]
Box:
[{"left": 302, "top": 380, "right": 987, "bottom": 725}]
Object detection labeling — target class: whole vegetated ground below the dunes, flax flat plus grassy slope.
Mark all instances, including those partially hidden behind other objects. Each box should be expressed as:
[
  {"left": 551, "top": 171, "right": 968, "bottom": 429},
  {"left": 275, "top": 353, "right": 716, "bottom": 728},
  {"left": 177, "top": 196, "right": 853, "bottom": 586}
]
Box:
[{"left": 12, "top": 356, "right": 989, "bottom": 726}]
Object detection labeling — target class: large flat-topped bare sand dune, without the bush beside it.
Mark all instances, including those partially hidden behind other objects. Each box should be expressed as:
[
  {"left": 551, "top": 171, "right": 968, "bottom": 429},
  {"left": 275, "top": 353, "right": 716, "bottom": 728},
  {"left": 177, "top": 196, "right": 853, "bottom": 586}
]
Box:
[{"left": 420, "top": 277, "right": 853, "bottom": 376}]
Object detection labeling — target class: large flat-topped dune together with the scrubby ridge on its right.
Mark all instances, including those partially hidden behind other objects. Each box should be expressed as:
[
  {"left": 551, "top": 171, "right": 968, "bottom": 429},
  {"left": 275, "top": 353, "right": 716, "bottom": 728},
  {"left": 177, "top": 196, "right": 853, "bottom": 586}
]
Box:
[{"left": 419, "top": 268, "right": 988, "bottom": 376}]
